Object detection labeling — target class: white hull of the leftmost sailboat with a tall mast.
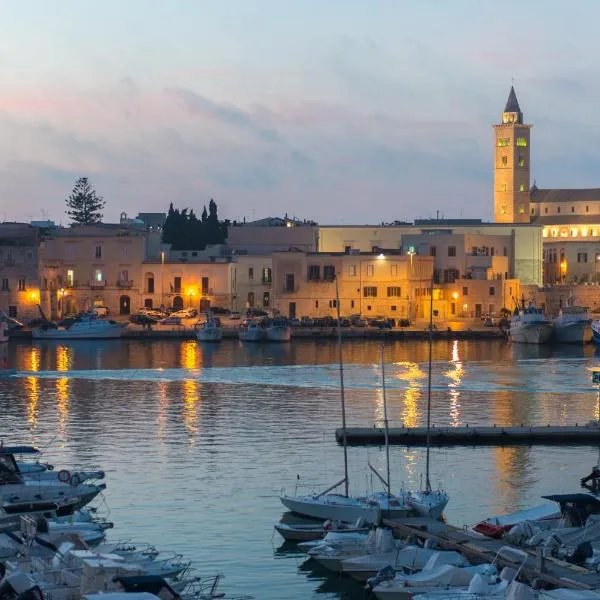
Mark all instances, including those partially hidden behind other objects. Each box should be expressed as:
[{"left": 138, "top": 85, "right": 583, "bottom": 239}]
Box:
[{"left": 280, "top": 496, "right": 381, "bottom": 523}]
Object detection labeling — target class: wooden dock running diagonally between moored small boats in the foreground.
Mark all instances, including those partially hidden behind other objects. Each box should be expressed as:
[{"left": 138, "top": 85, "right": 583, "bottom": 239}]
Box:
[{"left": 383, "top": 517, "right": 600, "bottom": 590}]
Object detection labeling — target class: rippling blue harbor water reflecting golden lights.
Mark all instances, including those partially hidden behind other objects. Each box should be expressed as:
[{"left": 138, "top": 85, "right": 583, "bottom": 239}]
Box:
[{"left": 0, "top": 340, "right": 600, "bottom": 600}]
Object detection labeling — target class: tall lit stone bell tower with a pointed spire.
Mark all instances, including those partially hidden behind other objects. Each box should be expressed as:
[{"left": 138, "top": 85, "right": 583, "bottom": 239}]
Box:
[{"left": 494, "top": 86, "right": 532, "bottom": 223}]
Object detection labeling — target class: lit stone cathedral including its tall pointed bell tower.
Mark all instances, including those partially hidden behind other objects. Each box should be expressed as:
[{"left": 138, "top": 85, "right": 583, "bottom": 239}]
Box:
[{"left": 493, "top": 87, "right": 600, "bottom": 283}]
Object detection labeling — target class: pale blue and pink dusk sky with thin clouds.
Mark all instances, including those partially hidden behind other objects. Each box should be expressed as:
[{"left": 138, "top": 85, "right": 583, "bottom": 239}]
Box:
[{"left": 0, "top": 0, "right": 600, "bottom": 224}]
